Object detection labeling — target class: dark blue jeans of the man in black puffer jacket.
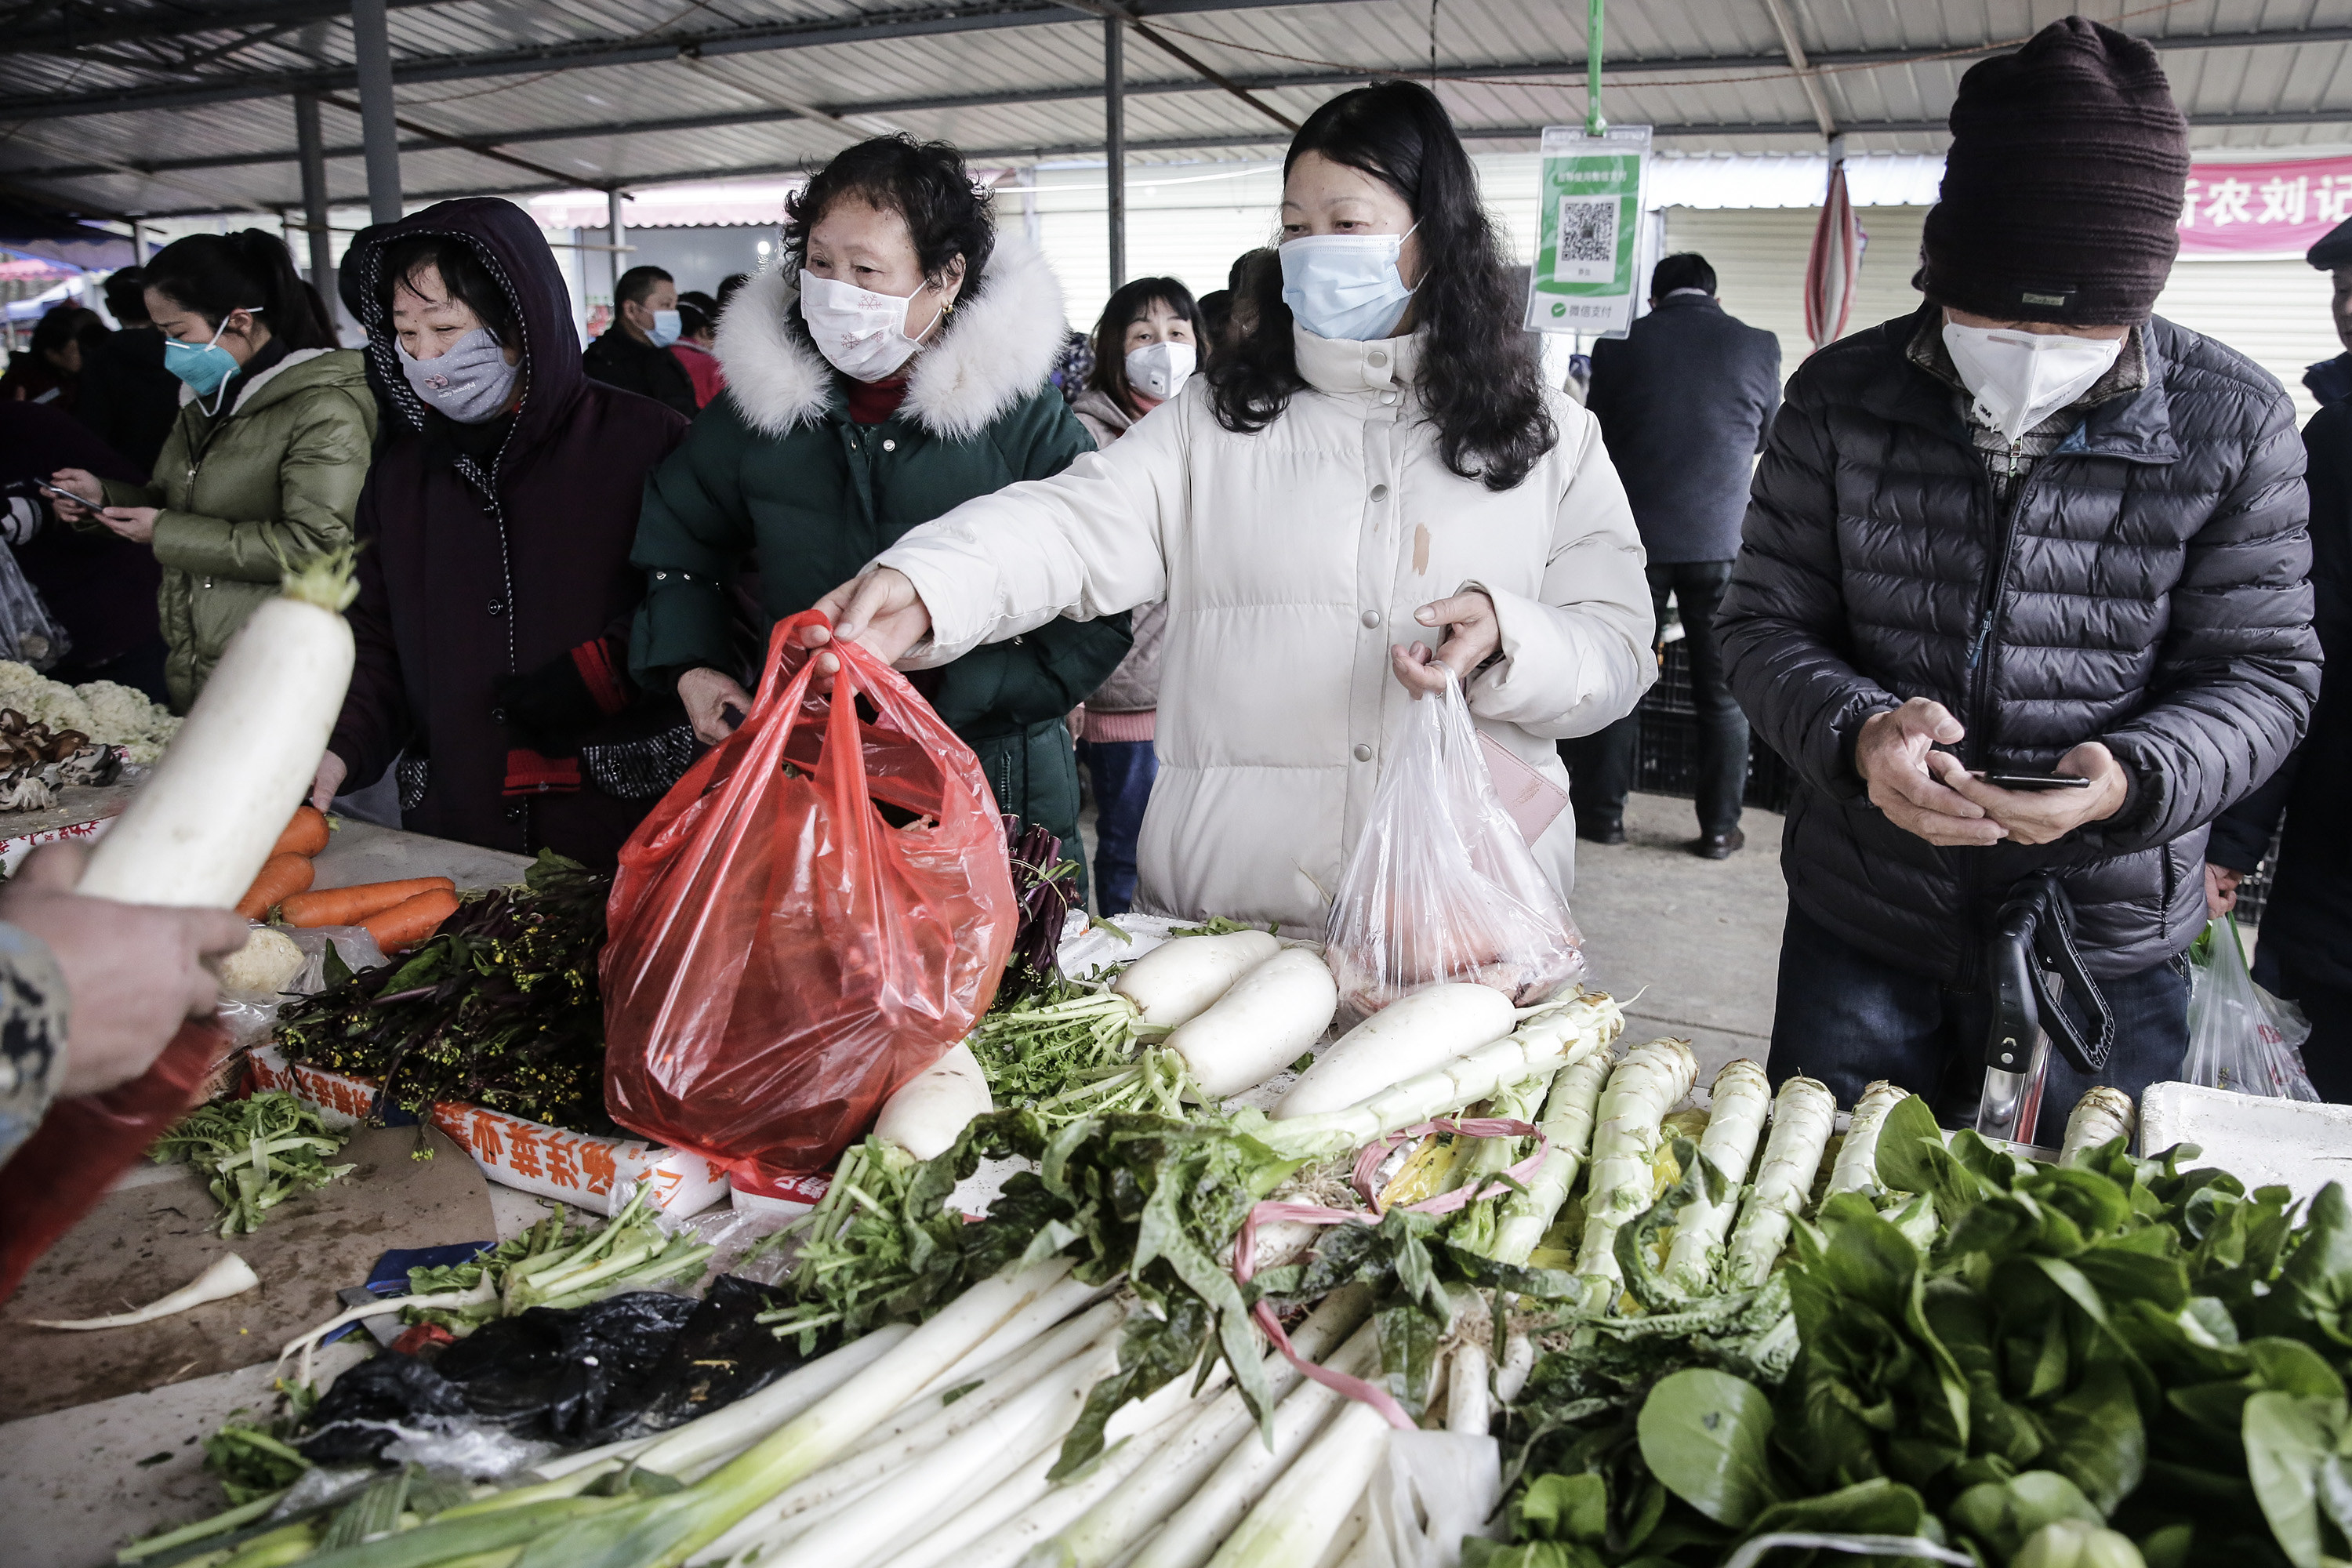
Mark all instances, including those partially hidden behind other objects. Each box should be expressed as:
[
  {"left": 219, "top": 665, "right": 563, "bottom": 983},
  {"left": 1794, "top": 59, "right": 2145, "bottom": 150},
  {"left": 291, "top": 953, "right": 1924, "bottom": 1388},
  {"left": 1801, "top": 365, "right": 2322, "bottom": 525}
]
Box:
[{"left": 1769, "top": 905, "right": 2190, "bottom": 1147}]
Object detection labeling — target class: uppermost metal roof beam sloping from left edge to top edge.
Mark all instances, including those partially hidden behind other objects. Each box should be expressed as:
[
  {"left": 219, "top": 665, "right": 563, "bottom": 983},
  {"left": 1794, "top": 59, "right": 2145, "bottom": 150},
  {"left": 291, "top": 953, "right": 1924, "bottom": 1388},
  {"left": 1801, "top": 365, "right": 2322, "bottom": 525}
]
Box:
[{"left": 0, "top": 0, "right": 1369, "bottom": 120}]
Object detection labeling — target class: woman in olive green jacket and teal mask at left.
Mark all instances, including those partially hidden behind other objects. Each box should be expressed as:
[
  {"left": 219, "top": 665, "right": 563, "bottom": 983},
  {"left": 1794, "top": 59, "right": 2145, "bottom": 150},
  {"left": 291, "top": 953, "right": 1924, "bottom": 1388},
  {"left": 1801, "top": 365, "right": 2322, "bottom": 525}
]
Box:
[{"left": 54, "top": 228, "right": 376, "bottom": 713}]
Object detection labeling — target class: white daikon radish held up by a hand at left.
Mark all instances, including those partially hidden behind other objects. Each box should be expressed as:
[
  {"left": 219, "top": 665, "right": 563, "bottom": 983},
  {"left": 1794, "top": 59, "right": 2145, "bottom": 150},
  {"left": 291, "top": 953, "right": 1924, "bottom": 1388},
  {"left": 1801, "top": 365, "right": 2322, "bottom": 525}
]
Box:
[{"left": 78, "top": 555, "right": 358, "bottom": 909}]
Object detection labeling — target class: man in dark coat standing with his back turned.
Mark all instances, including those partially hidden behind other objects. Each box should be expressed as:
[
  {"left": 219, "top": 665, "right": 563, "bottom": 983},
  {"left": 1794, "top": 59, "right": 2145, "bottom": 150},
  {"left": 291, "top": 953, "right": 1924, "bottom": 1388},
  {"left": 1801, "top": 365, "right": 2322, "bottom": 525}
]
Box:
[{"left": 1559, "top": 252, "right": 1780, "bottom": 860}]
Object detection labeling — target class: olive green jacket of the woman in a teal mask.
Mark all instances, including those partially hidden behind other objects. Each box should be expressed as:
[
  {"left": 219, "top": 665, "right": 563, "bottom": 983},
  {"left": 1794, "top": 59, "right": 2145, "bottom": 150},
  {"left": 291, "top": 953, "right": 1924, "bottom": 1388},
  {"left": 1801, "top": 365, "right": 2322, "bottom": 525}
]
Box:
[{"left": 106, "top": 348, "right": 376, "bottom": 713}]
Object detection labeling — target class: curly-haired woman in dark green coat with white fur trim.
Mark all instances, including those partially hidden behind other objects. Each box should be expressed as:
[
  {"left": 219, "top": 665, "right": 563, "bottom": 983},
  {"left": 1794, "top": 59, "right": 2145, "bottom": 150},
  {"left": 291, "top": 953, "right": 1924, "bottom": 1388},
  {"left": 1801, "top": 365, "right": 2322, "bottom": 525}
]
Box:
[{"left": 630, "top": 136, "right": 1129, "bottom": 902}]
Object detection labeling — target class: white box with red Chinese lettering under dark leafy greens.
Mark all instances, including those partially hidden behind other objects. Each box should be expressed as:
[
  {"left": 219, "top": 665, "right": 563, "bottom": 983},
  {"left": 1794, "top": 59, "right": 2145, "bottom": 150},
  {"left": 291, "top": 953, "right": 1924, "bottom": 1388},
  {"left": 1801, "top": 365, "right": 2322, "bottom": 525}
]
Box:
[{"left": 252, "top": 1046, "right": 727, "bottom": 1215}]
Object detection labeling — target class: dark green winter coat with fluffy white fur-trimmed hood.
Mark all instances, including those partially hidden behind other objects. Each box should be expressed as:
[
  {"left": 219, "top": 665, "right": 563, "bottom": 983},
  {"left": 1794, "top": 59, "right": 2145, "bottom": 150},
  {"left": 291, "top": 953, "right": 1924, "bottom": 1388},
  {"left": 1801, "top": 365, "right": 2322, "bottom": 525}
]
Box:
[{"left": 630, "top": 238, "right": 1129, "bottom": 888}]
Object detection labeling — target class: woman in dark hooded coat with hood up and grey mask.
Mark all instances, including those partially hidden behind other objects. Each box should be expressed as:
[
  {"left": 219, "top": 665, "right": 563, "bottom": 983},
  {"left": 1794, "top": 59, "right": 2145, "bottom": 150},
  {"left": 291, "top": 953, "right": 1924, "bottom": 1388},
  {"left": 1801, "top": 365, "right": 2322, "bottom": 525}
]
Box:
[{"left": 313, "top": 198, "right": 694, "bottom": 867}]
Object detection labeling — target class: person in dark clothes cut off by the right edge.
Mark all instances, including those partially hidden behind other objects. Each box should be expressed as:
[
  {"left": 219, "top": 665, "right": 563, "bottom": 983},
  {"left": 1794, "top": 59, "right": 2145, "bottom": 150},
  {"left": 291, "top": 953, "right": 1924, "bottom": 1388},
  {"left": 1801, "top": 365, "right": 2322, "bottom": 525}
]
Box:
[{"left": 2206, "top": 223, "right": 2352, "bottom": 1105}]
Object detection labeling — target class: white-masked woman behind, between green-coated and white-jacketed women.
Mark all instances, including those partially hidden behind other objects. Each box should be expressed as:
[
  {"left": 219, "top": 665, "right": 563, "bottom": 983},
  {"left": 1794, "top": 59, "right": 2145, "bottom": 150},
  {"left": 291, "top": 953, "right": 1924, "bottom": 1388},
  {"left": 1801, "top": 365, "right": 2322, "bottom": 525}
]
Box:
[{"left": 1070, "top": 278, "right": 1207, "bottom": 914}]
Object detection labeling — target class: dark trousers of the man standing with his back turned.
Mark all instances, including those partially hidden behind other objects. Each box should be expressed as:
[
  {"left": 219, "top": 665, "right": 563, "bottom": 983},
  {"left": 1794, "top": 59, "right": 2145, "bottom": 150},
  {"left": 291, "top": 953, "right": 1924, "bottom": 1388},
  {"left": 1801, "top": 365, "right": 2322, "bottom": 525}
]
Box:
[{"left": 1559, "top": 562, "right": 1748, "bottom": 834}]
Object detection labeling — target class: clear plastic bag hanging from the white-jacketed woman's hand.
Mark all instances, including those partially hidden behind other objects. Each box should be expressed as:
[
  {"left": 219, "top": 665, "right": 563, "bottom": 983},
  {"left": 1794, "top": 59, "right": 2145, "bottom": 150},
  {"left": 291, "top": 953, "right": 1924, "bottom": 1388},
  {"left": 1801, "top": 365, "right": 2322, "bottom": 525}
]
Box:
[{"left": 1324, "top": 680, "right": 1585, "bottom": 1027}]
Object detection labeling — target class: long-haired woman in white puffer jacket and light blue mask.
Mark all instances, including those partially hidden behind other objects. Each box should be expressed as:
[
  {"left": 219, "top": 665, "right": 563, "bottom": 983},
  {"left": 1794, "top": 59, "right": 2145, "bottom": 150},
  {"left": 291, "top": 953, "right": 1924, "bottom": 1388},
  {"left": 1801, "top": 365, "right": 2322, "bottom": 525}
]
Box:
[{"left": 809, "top": 82, "right": 1656, "bottom": 935}]
